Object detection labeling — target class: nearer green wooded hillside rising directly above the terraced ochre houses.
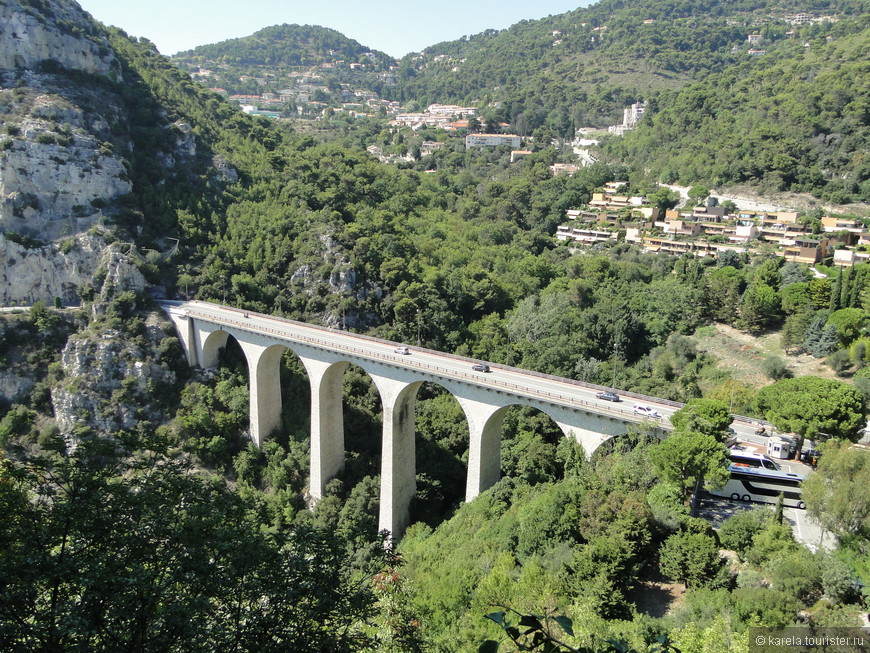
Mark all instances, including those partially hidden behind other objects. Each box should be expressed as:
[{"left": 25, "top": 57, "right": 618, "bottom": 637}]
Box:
[{"left": 606, "top": 15, "right": 870, "bottom": 204}]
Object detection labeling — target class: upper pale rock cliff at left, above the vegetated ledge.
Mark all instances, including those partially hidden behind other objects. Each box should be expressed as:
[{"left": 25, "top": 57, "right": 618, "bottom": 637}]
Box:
[{"left": 0, "top": 0, "right": 132, "bottom": 240}]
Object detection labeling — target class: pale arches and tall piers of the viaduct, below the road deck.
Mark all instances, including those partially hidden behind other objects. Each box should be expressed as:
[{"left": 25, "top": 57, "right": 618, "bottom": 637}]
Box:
[{"left": 194, "top": 323, "right": 620, "bottom": 534}]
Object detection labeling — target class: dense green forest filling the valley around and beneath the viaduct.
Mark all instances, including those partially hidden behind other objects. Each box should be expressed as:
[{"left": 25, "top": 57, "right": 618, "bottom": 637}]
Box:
[{"left": 0, "top": 3, "right": 870, "bottom": 653}]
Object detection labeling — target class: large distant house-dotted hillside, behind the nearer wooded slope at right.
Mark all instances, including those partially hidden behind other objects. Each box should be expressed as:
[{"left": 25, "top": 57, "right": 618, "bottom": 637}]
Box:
[{"left": 395, "top": 0, "right": 861, "bottom": 127}]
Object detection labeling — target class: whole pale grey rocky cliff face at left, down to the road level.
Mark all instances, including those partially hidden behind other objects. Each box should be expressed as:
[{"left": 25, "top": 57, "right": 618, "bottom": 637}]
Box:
[{"left": 0, "top": 0, "right": 196, "bottom": 305}]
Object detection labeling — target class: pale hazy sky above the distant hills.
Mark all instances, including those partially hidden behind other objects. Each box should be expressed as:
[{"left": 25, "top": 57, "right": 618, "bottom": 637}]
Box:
[{"left": 78, "top": 0, "right": 590, "bottom": 58}]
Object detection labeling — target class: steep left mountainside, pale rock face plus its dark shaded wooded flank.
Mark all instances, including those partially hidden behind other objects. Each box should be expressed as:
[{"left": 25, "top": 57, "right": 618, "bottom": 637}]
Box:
[{"left": 0, "top": 0, "right": 252, "bottom": 304}]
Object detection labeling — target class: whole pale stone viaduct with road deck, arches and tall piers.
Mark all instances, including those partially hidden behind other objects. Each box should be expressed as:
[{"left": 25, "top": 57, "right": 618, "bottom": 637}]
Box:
[{"left": 163, "top": 302, "right": 679, "bottom": 536}]
